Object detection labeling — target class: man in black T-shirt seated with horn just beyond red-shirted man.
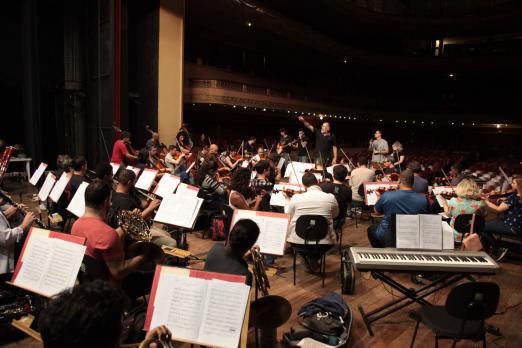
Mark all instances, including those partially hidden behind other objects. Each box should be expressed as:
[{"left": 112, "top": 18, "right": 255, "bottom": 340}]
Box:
[{"left": 108, "top": 169, "right": 176, "bottom": 246}]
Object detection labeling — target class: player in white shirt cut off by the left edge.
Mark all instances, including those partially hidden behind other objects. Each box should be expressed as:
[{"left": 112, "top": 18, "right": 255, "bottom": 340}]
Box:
[{"left": 0, "top": 205, "right": 35, "bottom": 280}]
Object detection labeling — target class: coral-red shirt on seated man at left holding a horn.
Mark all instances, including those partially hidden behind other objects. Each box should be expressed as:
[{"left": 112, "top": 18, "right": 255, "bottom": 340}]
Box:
[{"left": 71, "top": 217, "right": 124, "bottom": 261}]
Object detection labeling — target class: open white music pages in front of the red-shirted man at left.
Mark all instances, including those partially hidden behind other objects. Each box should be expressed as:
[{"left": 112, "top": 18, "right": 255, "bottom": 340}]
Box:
[{"left": 14, "top": 229, "right": 86, "bottom": 296}]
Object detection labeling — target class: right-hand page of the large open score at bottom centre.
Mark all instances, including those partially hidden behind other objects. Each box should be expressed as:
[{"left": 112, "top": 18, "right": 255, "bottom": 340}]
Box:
[{"left": 197, "top": 279, "right": 250, "bottom": 348}]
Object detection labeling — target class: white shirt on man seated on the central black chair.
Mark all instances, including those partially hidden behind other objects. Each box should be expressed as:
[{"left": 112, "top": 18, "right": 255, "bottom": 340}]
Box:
[{"left": 287, "top": 185, "right": 339, "bottom": 244}]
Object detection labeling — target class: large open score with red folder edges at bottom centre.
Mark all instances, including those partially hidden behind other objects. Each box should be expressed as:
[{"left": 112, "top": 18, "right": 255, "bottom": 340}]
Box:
[{"left": 144, "top": 266, "right": 250, "bottom": 348}]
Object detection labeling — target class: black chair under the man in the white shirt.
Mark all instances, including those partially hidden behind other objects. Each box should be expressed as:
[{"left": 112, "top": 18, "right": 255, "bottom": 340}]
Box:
[{"left": 291, "top": 215, "right": 333, "bottom": 288}]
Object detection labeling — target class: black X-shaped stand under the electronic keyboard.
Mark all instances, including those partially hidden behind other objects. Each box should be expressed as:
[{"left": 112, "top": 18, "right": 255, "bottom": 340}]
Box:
[{"left": 359, "top": 271, "right": 469, "bottom": 336}]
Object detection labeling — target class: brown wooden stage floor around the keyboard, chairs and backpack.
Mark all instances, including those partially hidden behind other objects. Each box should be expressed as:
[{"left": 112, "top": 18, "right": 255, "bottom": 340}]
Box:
[{"left": 0, "top": 181, "right": 522, "bottom": 348}]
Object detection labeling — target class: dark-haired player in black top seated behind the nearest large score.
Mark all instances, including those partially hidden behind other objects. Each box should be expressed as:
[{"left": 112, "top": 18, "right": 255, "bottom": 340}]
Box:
[{"left": 204, "top": 219, "right": 259, "bottom": 285}]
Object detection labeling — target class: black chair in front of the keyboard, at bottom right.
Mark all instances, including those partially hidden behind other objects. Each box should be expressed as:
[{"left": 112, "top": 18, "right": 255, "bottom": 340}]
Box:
[{"left": 410, "top": 282, "right": 500, "bottom": 348}]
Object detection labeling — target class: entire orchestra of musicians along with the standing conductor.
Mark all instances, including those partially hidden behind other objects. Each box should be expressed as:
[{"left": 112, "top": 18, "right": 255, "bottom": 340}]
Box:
[{"left": 0, "top": 116, "right": 522, "bottom": 348}]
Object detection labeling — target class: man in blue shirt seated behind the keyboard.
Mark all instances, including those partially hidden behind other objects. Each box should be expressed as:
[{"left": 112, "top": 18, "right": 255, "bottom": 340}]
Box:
[{"left": 368, "top": 169, "right": 428, "bottom": 248}]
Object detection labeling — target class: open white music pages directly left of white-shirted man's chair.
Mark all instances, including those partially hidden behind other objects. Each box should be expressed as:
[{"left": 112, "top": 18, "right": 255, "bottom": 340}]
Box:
[{"left": 233, "top": 209, "right": 289, "bottom": 256}]
